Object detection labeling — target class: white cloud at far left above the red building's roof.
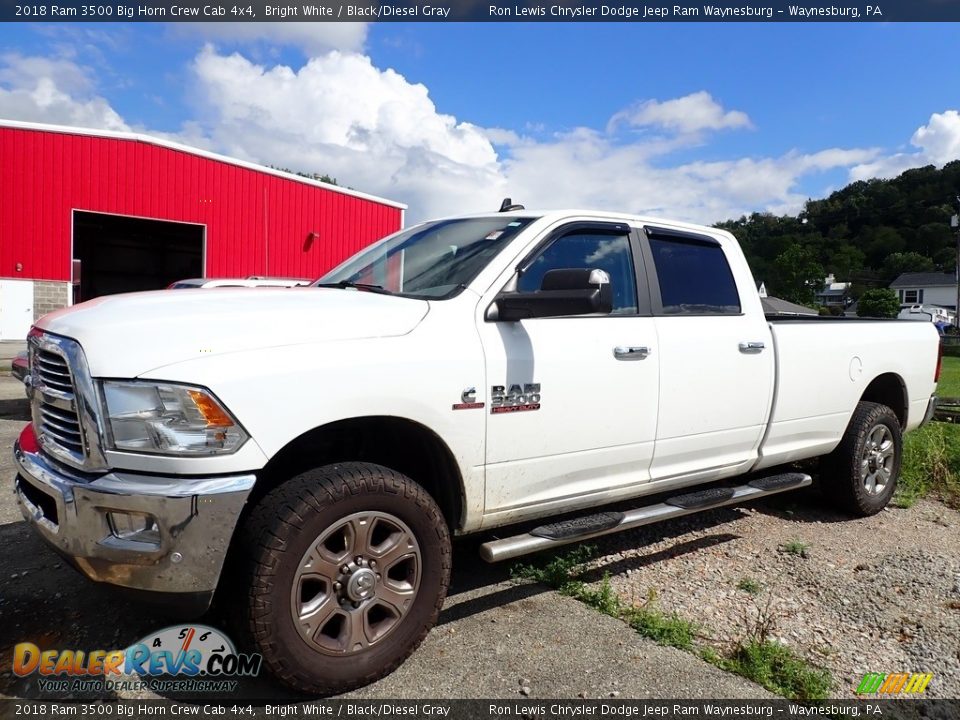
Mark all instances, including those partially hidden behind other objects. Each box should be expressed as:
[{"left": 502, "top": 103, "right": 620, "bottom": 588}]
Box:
[{"left": 0, "top": 53, "right": 129, "bottom": 130}]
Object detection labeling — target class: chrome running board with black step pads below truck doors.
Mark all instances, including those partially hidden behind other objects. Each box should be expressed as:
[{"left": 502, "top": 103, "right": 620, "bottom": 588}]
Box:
[{"left": 480, "top": 473, "right": 813, "bottom": 562}]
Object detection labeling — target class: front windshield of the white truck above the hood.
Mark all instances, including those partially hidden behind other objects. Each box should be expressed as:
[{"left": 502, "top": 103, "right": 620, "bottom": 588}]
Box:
[{"left": 315, "top": 216, "right": 534, "bottom": 299}]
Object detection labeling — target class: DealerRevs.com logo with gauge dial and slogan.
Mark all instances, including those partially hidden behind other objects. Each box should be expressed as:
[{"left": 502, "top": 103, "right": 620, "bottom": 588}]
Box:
[{"left": 13, "top": 625, "right": 263, "bottom": 692}]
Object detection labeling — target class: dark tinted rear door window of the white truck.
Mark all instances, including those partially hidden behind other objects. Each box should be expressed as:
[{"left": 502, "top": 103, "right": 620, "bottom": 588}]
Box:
[{"left": 650, "top": 237, "right": 740, "bottom": 315}]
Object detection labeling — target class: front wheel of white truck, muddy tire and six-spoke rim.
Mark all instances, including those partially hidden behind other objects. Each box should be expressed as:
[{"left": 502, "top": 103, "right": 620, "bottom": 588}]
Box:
[{"left": 240, "top": 463, "right": 451, "bottom": 695}]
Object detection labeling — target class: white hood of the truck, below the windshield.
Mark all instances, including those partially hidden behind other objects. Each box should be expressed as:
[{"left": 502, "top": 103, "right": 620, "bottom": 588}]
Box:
[{"left": 36, "top": 288, "right": 430, "bottom": 377}]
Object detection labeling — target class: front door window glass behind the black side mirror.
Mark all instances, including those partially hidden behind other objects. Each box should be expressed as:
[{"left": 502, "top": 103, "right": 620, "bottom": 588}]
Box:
[{"left": 517, "top": 233, "right": 637, "bottom": 315}]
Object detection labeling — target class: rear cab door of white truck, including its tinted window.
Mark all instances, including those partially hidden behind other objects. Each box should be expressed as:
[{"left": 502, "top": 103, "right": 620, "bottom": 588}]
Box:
[{"left": 641, "top": 226, "right": 774, "bottom": 481}]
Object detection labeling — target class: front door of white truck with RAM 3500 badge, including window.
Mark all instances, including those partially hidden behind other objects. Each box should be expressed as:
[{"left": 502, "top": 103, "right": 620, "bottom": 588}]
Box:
[{"left": 478, "top": 223, "right": 659, "bottom": 521}]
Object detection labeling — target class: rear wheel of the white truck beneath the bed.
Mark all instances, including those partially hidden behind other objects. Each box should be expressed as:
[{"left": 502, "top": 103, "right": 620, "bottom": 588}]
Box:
[{"left": 820, "top": 402, "right": 903, "bottom": 517}]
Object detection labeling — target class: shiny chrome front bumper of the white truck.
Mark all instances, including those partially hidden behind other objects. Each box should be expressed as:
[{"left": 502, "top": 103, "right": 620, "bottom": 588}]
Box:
[{"left": 13, "top": 426, "right": 256, "bottom": 612}]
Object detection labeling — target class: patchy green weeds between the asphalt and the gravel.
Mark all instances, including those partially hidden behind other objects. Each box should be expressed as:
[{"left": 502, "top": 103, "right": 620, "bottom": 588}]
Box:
[{"left": 510, "top": 543, "right": 833, "bottom": 700}]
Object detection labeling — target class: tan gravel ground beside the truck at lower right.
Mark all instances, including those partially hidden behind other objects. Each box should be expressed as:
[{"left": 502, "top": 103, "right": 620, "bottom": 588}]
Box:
[{"left": 594, "top": 491, "right": 960, "bottom": 698}]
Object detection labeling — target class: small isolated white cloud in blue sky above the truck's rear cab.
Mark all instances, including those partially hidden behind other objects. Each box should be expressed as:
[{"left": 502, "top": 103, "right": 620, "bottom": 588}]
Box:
[{"left": 608, "top": 90, "right": 753, "bottom": 133}]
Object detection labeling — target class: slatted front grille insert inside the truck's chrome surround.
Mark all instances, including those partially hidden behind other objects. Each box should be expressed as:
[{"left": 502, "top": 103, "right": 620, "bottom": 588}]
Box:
[{"left": 30, "top": 341, "right": 87, "bottom": 467}]
